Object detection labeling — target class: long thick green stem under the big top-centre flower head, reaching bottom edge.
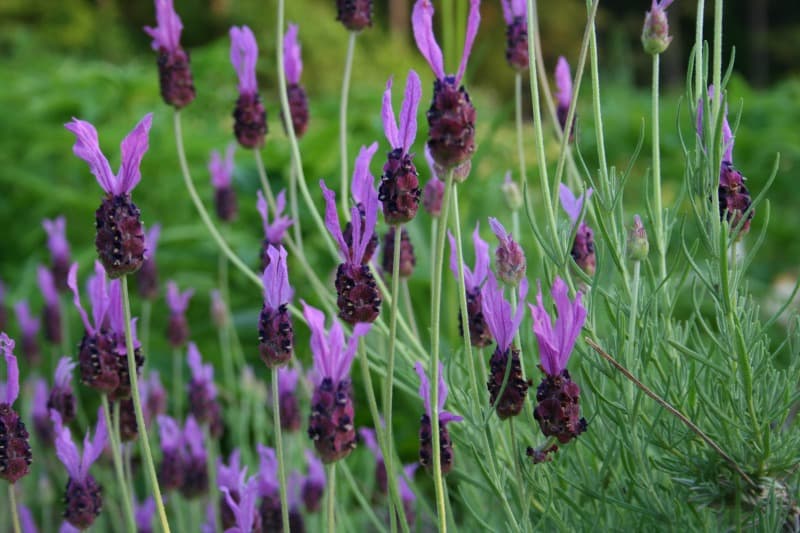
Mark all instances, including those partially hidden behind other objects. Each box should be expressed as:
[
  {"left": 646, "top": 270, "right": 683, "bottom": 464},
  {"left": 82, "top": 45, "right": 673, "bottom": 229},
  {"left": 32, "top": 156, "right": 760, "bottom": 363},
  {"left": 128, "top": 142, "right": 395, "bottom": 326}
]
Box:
[{"left": 429, "top": 169, "right": 454, "bottom": 533}]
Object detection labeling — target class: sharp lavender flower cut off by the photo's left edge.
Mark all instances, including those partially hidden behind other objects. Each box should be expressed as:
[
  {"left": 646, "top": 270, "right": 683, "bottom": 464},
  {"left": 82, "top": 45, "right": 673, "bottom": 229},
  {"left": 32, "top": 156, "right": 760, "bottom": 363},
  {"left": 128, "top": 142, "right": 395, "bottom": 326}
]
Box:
[{"left": 0, "top": 333, "right": 33, "bottom": 484}]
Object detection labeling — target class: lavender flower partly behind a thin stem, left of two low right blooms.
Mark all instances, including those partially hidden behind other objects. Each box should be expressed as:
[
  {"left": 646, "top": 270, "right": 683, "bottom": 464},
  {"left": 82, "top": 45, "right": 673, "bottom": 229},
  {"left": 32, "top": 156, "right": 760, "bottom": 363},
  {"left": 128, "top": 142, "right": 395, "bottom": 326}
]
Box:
[{"left": 447, "top": 224, "right": 492, "bottom": 348}]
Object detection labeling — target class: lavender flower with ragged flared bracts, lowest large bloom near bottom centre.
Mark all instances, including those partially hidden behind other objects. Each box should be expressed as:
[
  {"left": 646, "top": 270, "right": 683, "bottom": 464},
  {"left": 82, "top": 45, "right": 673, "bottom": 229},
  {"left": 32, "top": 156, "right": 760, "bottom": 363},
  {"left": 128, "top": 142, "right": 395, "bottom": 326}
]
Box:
[{"left": 303, "top": 302, "right": 371, "bottom": 463}]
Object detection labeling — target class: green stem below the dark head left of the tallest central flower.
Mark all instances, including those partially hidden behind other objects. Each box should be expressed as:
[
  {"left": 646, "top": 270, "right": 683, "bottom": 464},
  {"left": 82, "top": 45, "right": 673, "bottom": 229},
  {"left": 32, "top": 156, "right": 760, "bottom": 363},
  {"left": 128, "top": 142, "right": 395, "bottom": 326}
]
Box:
[{"left": 383, "top": 226, "right": 405, "bottom": 531}]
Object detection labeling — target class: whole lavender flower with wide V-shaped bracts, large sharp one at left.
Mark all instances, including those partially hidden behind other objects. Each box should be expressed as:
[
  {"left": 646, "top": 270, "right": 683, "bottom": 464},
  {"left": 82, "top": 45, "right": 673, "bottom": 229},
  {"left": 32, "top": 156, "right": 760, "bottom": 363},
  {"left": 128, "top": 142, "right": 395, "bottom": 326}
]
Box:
[{"left": 65, "top": 113, "right": 153, "bottom": 278}]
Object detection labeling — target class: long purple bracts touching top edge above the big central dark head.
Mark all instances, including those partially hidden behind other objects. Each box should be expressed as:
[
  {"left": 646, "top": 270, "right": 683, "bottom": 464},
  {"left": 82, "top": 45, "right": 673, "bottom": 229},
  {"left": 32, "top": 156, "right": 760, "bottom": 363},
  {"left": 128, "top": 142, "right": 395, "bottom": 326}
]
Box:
[{"left": 411, "top": 0, "right": 481, "bottom": 86}]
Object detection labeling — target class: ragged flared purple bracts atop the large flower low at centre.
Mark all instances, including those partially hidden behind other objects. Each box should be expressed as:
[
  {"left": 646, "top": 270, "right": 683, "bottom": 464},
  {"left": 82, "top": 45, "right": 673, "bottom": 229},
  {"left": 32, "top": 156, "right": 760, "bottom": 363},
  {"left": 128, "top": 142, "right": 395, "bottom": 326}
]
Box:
[{"left": 303, "top": 302, "right": 371, "bottom": 386}]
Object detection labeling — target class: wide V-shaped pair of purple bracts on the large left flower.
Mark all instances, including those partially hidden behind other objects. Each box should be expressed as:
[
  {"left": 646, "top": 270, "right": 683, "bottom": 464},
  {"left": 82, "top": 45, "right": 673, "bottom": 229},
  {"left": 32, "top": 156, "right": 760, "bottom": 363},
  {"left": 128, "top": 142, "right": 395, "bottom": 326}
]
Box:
[{"left": 64, "top": 113, "right": 153, "bottom": 196}]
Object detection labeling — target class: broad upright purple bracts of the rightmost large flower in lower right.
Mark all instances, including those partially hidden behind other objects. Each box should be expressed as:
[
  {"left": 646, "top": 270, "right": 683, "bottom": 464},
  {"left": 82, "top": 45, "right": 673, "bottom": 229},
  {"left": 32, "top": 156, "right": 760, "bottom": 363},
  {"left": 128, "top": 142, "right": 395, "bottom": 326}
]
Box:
[{"left": 528, "top": 277, "right": 586, "bottom": 376}]
